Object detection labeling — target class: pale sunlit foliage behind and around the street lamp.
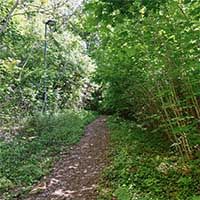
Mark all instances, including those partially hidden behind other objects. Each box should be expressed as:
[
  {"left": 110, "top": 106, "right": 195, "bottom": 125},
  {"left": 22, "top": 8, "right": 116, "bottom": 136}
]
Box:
[{"left": 0, "top": 0, "right": 95, "bottom": 126}]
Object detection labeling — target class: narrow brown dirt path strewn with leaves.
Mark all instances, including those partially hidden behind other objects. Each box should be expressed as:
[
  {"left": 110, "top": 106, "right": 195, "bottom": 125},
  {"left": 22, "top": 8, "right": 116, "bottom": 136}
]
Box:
[{"left": 26, "top": 116, "right": 108, "bottom": 200}]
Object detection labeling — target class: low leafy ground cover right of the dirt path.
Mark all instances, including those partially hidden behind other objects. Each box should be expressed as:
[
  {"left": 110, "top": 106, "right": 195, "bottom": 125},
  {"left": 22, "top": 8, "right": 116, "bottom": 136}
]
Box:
[{"left": 99, "top": 118, "right": 200, "bottom": 200}]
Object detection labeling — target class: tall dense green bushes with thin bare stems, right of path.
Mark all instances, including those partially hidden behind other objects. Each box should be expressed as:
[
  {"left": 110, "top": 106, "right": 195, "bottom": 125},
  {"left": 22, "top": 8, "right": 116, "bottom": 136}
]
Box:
[{"left": 86, "top": 0, "right": 200, "bottom": 160}]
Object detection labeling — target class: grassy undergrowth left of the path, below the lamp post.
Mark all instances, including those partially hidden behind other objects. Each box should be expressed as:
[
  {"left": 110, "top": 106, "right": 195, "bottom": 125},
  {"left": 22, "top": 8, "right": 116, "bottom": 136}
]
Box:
[{"left": 0, "top": 110, "right": 95, "bottom": 199}]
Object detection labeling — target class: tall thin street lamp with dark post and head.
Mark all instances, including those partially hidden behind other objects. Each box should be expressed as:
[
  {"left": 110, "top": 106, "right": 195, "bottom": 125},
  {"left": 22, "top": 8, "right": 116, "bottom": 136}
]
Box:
[{"left": 42, "top": 19, "right": 56, "bottom": 113}]
